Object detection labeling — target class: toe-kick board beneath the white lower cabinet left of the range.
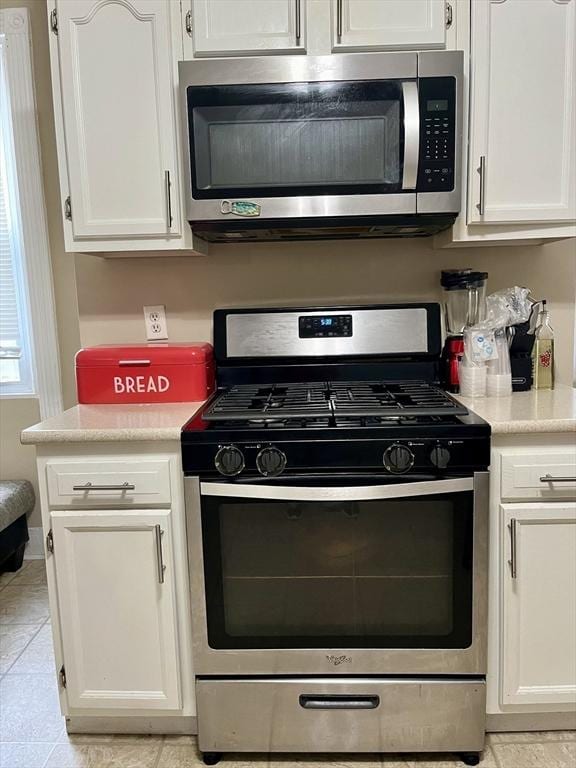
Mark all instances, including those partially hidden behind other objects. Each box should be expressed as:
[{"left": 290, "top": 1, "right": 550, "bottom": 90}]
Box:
[{"left": 66, "top": 715, "right": 198, "bottom": 736}]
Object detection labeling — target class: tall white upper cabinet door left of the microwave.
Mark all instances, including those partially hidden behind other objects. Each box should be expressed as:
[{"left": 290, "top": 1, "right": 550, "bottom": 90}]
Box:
[{"left": 56, "top": 0, "right": 180, "bottom": 239}]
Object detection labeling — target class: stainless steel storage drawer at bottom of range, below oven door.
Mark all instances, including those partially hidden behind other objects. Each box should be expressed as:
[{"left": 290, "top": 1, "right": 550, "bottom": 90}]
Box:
[{"left": 196, "top": 678, "right": 486, "bottom": 752}]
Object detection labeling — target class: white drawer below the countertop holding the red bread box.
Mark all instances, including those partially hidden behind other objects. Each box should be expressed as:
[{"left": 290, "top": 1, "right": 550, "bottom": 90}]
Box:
[{"left": 46, "top": 458, "right": 170, "bottom": 507}]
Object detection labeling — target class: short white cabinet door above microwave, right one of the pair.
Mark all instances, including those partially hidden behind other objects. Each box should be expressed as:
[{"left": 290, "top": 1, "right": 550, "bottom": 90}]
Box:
[{"left": 332, "top": 0, "right": 446, "bottom": 51}]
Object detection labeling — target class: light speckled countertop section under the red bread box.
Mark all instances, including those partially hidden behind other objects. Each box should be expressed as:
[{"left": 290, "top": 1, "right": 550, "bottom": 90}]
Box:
[{"left": 21, "top": 401, "right": 204, "bottom": 444}]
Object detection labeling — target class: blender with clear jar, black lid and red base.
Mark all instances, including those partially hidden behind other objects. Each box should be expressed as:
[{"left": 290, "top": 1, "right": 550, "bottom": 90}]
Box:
[{"left": 440, "top": 269, "right": 488, "bottom": 392}]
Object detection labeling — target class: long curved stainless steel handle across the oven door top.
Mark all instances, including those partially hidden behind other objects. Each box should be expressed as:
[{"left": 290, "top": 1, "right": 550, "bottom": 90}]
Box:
[{"left": 200, "top": 477, "right": 474, "bottom": 502}]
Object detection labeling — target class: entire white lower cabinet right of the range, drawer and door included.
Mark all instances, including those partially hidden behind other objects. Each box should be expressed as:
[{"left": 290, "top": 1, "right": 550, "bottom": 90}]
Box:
[{"left": 486, "top": 433, "right": 576, "bottom": 731}]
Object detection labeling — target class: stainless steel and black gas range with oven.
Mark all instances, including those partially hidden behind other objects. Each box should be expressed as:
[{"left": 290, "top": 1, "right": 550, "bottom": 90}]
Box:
[{"left": 182, "top": 304, "right": 490, "bottom": 765}]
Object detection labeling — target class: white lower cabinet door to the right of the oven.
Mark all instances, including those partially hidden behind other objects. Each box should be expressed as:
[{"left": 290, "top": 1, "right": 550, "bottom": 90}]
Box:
[{"left": 501, "top": 502, "right": 576, "bottom": 705}]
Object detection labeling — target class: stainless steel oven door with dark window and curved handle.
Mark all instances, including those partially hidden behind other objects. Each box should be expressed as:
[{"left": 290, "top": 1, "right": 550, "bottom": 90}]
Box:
[{"left": 186, "top": 473, "right": 488, "bottom": 675}]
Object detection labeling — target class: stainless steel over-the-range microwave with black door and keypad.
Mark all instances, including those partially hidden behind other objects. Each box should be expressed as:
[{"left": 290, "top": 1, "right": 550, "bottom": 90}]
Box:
[{"left": 179, "top": 51, "right": 463, "bottom": 242}]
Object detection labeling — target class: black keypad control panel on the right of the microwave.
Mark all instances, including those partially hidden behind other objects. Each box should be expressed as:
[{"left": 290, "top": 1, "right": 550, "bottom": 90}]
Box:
[{"left": 417, "top": 77, "right": 456, "bottom": 192}]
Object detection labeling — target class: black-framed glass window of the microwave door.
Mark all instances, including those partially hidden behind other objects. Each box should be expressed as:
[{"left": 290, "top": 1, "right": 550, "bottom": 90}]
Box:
[{"left": 187, "top": 81, "right": 404, "bottom": 200}]
